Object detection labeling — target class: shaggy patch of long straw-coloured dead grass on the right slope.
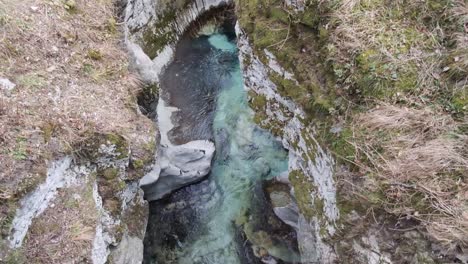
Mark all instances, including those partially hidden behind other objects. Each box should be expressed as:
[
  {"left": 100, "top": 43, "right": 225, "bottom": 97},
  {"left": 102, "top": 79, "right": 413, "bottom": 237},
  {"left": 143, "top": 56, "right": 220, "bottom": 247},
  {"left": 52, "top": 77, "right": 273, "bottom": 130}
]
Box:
[{"left": 350, "top": 104, "right": 468, "bottom": 251}]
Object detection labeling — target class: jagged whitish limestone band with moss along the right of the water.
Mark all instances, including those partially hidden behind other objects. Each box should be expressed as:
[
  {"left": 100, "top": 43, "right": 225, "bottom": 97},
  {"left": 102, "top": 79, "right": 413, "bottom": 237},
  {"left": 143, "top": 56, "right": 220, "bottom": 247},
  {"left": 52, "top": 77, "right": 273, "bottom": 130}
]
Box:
[{"left": 236, "top": 23, "right": 339, "bottom": 263}]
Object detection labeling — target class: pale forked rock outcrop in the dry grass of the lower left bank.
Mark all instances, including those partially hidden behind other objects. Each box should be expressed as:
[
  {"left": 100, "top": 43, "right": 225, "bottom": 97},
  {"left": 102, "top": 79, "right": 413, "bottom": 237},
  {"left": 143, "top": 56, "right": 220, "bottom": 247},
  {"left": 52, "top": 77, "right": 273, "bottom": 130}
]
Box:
[{"left": 9, "top": 145, "right": 146, "bottom": 264}]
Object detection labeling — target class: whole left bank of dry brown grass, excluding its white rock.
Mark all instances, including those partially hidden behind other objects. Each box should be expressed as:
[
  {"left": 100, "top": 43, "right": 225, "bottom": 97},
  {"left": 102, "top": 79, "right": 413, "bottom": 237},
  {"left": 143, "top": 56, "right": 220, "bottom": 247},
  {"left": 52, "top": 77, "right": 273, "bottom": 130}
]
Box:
[{"left": 0, "top": 0, "right": 157, "bottom": 263}]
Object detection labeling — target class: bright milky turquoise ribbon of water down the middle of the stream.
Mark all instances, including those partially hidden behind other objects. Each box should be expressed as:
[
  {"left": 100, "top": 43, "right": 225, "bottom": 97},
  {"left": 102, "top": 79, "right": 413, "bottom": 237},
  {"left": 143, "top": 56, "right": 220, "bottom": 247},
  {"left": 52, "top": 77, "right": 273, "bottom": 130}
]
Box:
[{"left": 180, "top": 35, "right": 288, "bottom": 264}]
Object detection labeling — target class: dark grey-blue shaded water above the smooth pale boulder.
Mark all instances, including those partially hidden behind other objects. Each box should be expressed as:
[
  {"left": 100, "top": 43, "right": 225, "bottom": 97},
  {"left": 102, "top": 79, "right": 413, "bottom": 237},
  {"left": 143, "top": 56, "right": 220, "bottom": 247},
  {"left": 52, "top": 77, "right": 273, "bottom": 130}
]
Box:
[{"left": 161, "top": 11, "right": 238, "bottom": 144}]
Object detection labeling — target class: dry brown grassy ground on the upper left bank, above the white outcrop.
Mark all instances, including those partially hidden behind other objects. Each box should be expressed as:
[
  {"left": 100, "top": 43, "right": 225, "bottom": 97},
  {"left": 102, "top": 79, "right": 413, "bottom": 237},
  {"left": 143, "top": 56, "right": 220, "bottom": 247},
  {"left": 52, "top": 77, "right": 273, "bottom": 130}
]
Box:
[{"left": 0, "top": 0, "right": 154, "bottom": 260}]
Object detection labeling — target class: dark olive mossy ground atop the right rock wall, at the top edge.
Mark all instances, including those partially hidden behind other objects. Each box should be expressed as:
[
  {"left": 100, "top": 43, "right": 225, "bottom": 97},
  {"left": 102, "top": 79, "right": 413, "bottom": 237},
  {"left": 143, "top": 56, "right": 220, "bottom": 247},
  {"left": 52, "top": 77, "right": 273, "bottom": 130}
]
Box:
[{"left": 237, "top": 0, "right": 335, "bottom": 114}]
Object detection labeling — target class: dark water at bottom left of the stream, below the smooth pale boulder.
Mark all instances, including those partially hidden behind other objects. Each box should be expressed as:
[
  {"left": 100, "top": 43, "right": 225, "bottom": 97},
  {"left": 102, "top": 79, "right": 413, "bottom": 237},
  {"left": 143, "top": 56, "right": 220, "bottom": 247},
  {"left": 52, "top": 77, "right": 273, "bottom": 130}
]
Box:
[{"left": 145, "top": 179, "right": 221, "bottom": 263}]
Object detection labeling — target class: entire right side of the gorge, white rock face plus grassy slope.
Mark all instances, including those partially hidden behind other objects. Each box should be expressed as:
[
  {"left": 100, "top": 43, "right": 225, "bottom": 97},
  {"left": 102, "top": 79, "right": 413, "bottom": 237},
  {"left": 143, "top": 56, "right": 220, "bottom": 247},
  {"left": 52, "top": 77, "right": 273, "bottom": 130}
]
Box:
[{"left": 236, "top": 0, "right": 468, "bottom": 263}]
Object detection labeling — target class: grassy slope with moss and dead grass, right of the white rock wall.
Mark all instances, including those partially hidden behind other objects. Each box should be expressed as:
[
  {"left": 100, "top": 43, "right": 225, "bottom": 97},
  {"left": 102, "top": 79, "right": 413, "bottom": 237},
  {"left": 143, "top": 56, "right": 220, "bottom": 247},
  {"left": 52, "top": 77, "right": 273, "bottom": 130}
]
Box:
[{"left": 237, "top": 0, "right": 468, "bottom": 258}]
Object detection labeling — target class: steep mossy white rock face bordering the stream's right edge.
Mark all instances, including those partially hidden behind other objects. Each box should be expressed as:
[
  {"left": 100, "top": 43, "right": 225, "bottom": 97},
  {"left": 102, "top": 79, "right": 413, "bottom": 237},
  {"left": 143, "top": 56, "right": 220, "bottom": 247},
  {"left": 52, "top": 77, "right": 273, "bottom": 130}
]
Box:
[{"left": 237, "top": 24, "right": 339, "bottom": 263}]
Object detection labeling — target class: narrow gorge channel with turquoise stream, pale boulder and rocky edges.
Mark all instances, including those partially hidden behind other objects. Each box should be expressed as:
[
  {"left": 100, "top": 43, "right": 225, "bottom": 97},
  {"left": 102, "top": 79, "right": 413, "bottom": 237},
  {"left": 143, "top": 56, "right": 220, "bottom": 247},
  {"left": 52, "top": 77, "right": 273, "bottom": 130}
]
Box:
[{"left": 124, "top": 1, "right": 337, "bottom": 263}]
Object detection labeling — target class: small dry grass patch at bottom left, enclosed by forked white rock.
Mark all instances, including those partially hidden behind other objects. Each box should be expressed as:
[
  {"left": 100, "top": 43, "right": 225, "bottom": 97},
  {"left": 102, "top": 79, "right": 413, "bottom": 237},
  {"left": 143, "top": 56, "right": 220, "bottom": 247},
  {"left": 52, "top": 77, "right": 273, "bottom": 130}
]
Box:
[{"left": 23, "top": 184, "right": 99, "bottom": 264}]
